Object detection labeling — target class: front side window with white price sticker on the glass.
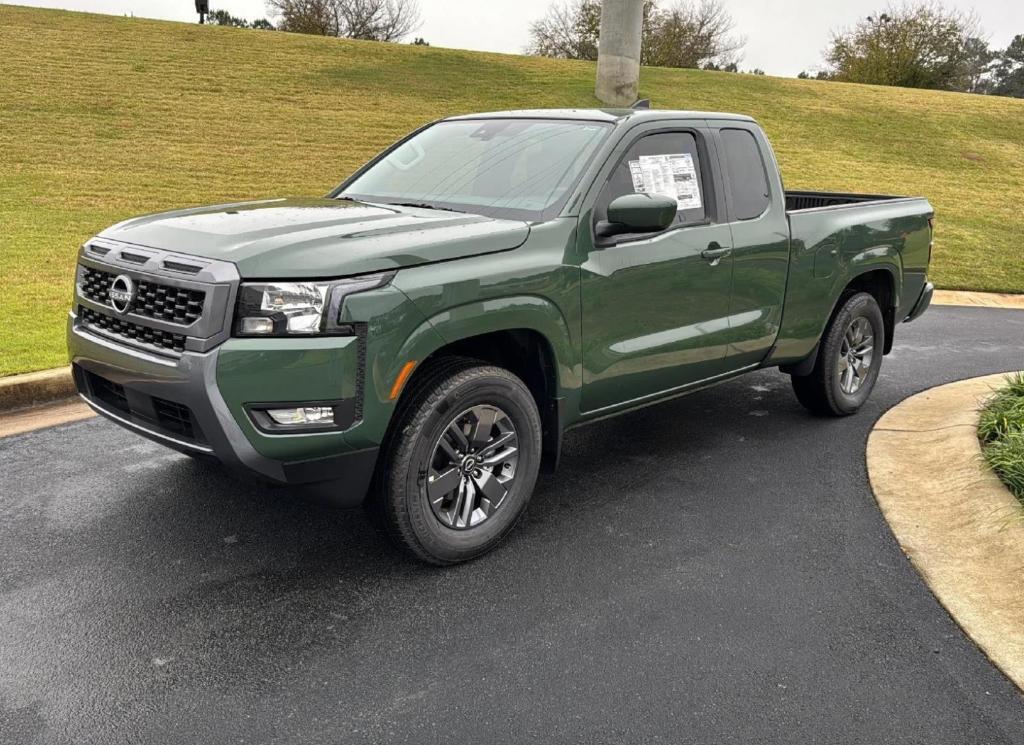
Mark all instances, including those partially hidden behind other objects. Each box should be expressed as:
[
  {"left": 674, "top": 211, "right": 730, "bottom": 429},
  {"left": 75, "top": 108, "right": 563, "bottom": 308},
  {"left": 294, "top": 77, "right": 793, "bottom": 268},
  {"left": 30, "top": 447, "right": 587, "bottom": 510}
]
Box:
[{"left": 594, "top": 132, "right": 708, "bottom": 225}]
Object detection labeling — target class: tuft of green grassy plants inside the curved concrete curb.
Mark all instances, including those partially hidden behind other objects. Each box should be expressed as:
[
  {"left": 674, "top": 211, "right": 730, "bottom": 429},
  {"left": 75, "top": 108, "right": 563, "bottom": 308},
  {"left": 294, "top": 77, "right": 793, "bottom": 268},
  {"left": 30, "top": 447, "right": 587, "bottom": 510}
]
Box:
[{"left": 978, "top": 374, "right": 1024, "bottom": 502}]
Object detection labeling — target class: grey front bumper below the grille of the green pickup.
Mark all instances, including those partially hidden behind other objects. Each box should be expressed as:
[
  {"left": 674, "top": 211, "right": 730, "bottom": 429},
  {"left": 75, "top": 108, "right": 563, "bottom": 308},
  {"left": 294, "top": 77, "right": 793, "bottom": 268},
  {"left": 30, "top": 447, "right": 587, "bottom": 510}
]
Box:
[{"left": 68, "top": 313, "right": 377, "bottom": 506}]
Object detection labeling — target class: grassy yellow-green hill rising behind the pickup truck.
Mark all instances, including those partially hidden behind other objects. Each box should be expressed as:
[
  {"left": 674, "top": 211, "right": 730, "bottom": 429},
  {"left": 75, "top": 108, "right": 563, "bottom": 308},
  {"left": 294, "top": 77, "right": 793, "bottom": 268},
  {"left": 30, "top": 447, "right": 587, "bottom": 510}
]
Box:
[{"left": 0, "top": 5, "right": 1024, "bottom": 375}]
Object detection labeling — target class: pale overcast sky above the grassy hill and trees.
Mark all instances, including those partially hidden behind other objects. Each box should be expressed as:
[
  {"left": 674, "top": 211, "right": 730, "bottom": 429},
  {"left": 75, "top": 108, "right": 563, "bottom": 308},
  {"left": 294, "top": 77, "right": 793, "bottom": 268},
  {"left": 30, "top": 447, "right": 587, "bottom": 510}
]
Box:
[{"left": 16, "top": 0, "right": 1024, "bottom": 76}]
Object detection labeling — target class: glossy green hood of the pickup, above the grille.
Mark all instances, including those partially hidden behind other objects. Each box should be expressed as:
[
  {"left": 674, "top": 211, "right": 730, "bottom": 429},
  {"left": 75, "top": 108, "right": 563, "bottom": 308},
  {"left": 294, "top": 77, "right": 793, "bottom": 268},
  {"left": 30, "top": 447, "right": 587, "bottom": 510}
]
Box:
[{"left": 100, "top": 199, "right": 529, "bottom": 279}]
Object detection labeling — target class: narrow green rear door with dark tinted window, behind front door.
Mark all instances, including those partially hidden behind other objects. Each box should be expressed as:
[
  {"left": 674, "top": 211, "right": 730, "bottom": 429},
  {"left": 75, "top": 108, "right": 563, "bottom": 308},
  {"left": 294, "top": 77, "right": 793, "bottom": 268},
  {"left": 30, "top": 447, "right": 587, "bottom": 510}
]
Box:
[{"left": 711, "top": 121, "right": 790, "bottom": 368}]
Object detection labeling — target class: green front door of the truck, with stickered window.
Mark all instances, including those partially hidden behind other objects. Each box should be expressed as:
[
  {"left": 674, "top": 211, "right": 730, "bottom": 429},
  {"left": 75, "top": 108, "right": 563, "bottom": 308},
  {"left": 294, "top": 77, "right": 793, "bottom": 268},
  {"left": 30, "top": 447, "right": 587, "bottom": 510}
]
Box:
[{"left": 581, "top": 129, "right": 732, "bottom": 412}]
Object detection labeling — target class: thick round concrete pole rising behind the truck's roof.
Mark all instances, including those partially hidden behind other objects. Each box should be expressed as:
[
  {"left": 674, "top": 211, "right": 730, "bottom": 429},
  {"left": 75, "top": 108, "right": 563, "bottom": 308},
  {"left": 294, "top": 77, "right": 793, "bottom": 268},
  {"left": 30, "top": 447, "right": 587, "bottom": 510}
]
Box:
[{"left": 594, "top": 0, "right": 644, "bottom": 106}]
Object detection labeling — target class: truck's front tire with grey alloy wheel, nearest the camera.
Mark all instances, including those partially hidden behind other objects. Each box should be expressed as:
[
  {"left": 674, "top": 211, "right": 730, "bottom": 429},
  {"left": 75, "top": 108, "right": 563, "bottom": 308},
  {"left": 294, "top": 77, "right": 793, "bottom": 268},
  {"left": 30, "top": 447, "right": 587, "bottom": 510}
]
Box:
[{"left": 371, "top": 358, "right": 541, "bottom": 566}]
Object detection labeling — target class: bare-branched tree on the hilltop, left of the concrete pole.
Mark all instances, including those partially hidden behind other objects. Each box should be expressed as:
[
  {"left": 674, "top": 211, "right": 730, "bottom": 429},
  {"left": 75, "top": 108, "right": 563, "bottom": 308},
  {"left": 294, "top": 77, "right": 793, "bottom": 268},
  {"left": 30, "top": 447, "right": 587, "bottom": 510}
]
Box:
[{"left": 267, "top": 0, "right": 420, "bottom": 41}]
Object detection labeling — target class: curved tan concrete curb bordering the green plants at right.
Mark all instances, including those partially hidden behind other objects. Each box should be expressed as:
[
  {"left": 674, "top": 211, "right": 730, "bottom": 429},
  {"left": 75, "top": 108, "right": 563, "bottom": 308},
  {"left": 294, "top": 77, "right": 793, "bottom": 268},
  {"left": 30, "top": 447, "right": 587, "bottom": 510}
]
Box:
[{"left": 867, "top": 374, "right": 1024, "bottom": 690}]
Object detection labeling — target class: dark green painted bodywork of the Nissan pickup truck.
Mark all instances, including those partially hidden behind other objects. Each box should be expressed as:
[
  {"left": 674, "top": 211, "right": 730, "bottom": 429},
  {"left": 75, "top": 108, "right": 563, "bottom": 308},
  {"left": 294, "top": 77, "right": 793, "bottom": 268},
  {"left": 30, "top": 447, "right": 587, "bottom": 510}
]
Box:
[{"left": 90, "top": 111, "right": 932, "bottom": 470}]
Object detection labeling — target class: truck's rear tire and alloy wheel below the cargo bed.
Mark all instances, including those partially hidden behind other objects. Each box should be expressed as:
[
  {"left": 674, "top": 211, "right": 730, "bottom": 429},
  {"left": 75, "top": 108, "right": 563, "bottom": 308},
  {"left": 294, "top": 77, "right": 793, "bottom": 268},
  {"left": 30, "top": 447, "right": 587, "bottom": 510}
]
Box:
[{"left": 791, "top": 293, "right": 886, "bottom": 417}]
